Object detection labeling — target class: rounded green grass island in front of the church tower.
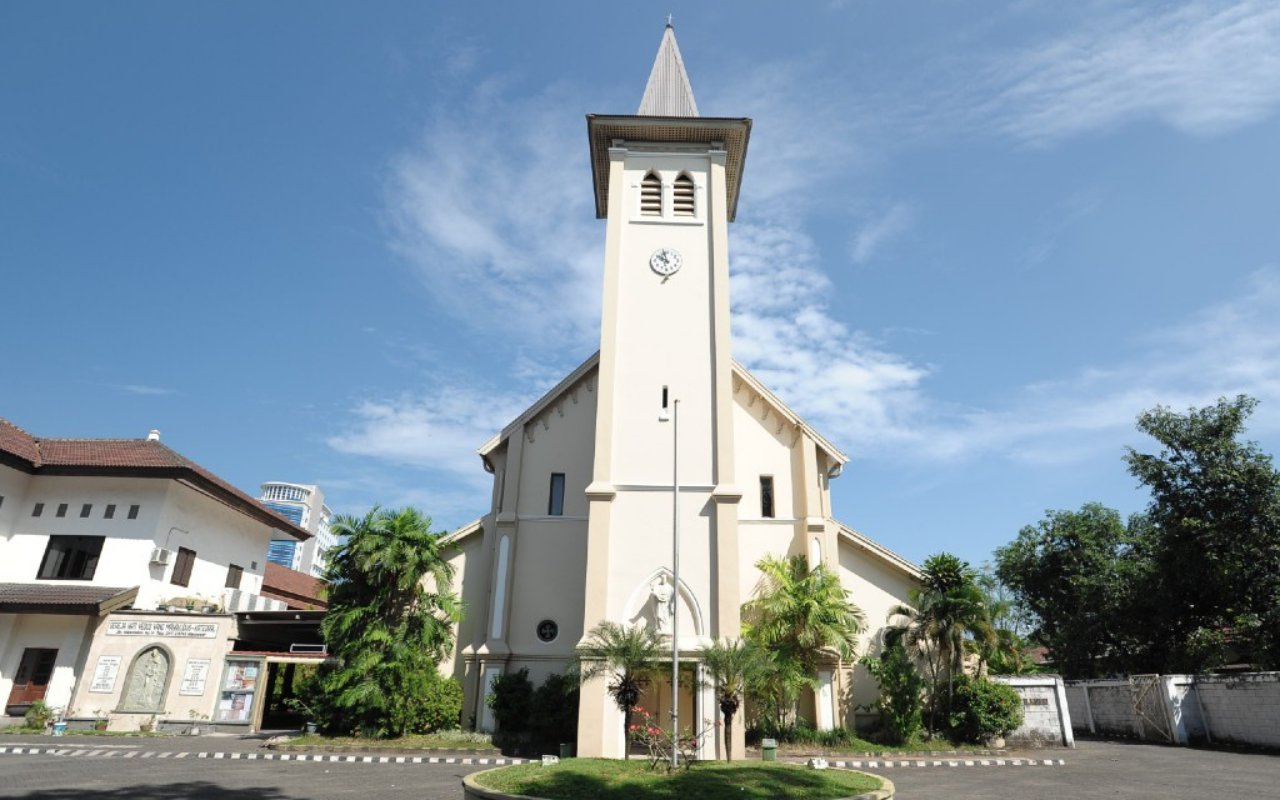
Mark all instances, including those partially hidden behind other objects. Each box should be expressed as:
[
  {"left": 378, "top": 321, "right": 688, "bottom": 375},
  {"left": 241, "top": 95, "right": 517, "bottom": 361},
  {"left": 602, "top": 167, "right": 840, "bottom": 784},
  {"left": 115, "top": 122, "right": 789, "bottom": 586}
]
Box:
[{"left": 476, "top": 758, "right": 881, "bottom": 800}]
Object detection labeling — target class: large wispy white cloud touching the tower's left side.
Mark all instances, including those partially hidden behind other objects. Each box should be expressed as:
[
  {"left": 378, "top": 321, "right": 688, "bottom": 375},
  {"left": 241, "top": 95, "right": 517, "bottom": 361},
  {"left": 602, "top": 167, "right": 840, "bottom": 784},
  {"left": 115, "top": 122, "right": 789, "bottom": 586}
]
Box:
[{"left": 388, "top": 81, "right": 603, "bottom": 348}]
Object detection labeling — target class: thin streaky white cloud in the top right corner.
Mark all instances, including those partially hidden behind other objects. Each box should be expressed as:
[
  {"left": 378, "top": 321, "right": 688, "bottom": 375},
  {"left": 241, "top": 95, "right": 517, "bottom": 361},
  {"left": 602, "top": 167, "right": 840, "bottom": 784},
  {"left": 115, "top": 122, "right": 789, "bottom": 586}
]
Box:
[{"left": 966, "top": 0, "right": 1280, "bottom": 143}]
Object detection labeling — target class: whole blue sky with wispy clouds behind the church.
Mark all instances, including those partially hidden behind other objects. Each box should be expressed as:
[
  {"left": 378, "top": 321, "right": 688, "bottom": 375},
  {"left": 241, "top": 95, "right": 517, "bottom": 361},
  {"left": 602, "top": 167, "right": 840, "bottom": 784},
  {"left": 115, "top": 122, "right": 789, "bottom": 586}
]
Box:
[{"left": 0, "top": 0, "right": 1280, "bottom": 563}]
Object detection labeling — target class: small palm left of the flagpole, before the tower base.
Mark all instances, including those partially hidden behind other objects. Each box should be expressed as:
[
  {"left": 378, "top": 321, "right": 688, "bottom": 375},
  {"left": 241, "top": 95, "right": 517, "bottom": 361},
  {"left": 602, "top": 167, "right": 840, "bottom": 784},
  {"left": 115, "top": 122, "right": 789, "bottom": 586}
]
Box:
[{"left": 577, "top": 621, "right": 662, "bottom": 759}]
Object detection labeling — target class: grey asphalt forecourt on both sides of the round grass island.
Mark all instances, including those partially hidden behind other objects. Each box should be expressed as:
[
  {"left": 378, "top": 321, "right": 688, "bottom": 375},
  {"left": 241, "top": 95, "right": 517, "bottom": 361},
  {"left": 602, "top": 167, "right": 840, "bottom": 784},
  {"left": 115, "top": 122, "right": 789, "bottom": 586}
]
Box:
[{"left": 0, "top": 737, "right": 1280, "bottom": 800}]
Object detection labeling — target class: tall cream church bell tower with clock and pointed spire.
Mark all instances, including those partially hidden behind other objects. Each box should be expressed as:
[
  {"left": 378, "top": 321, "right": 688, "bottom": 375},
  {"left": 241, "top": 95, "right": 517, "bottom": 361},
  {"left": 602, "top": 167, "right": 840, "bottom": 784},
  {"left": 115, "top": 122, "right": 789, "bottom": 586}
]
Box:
[{"left": 579, "top": 23, "right": 751, "bottom": 756}]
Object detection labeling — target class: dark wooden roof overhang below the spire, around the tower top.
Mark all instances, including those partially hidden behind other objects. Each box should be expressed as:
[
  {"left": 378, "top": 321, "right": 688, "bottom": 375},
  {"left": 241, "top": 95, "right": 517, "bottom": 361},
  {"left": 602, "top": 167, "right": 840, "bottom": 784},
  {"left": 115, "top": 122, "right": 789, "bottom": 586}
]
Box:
[{"left": 586, "top": 114, "right": 751, "bottom": 221}]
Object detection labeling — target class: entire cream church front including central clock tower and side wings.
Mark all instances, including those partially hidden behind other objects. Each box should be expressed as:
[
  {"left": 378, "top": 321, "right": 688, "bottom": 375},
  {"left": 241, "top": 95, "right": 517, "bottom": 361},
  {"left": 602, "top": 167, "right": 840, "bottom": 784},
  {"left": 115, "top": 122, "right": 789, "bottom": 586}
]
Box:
[{"left": 444, "top": 26, "right": 919, "bottom": 758}]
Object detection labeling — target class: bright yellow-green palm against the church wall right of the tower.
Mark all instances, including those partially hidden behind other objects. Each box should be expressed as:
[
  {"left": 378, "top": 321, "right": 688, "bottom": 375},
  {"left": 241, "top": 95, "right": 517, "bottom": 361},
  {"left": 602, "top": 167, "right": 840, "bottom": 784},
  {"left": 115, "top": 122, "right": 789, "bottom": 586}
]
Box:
[{"left": 742, "top": 556, "right": 867, "bottom": 724}]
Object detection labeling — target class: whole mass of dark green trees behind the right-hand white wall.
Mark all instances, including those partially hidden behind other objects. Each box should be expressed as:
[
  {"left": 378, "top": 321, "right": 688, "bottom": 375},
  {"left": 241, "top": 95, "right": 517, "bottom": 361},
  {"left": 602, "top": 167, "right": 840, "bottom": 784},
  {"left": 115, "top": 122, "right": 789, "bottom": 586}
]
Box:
[{"left": 997, "top": 396, "right": 1280, "bottom": 678}]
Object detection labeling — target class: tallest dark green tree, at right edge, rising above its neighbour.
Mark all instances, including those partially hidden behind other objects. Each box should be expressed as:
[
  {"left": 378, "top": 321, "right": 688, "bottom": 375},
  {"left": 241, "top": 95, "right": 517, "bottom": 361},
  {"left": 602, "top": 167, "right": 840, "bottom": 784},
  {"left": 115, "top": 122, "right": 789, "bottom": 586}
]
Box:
[{"left": 1125, "top": 396, "right": 1280, "bottom": 671}]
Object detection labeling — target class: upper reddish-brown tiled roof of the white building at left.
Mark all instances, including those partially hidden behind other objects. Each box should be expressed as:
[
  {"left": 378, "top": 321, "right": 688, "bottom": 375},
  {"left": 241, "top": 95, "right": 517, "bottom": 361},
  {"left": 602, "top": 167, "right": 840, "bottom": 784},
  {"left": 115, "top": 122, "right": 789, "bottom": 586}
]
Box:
[{"left": 0, "top": 417, "right": 311, "bottom": 539}]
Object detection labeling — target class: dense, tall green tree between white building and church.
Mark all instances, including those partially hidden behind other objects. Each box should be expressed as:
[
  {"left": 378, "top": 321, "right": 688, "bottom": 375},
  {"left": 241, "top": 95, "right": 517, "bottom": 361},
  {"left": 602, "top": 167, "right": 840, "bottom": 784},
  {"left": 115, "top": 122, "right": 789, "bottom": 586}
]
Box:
[{"left": 317, "top": 508, "right": 462, "bottom": 737}]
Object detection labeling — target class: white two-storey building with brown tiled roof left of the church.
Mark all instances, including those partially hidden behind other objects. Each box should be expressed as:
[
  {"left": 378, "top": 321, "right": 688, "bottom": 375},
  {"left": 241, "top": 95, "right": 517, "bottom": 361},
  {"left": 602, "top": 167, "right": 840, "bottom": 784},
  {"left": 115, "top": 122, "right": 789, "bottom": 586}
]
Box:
[{"left": 0, "top": 420, "right": 310, "bottom": 727}]
